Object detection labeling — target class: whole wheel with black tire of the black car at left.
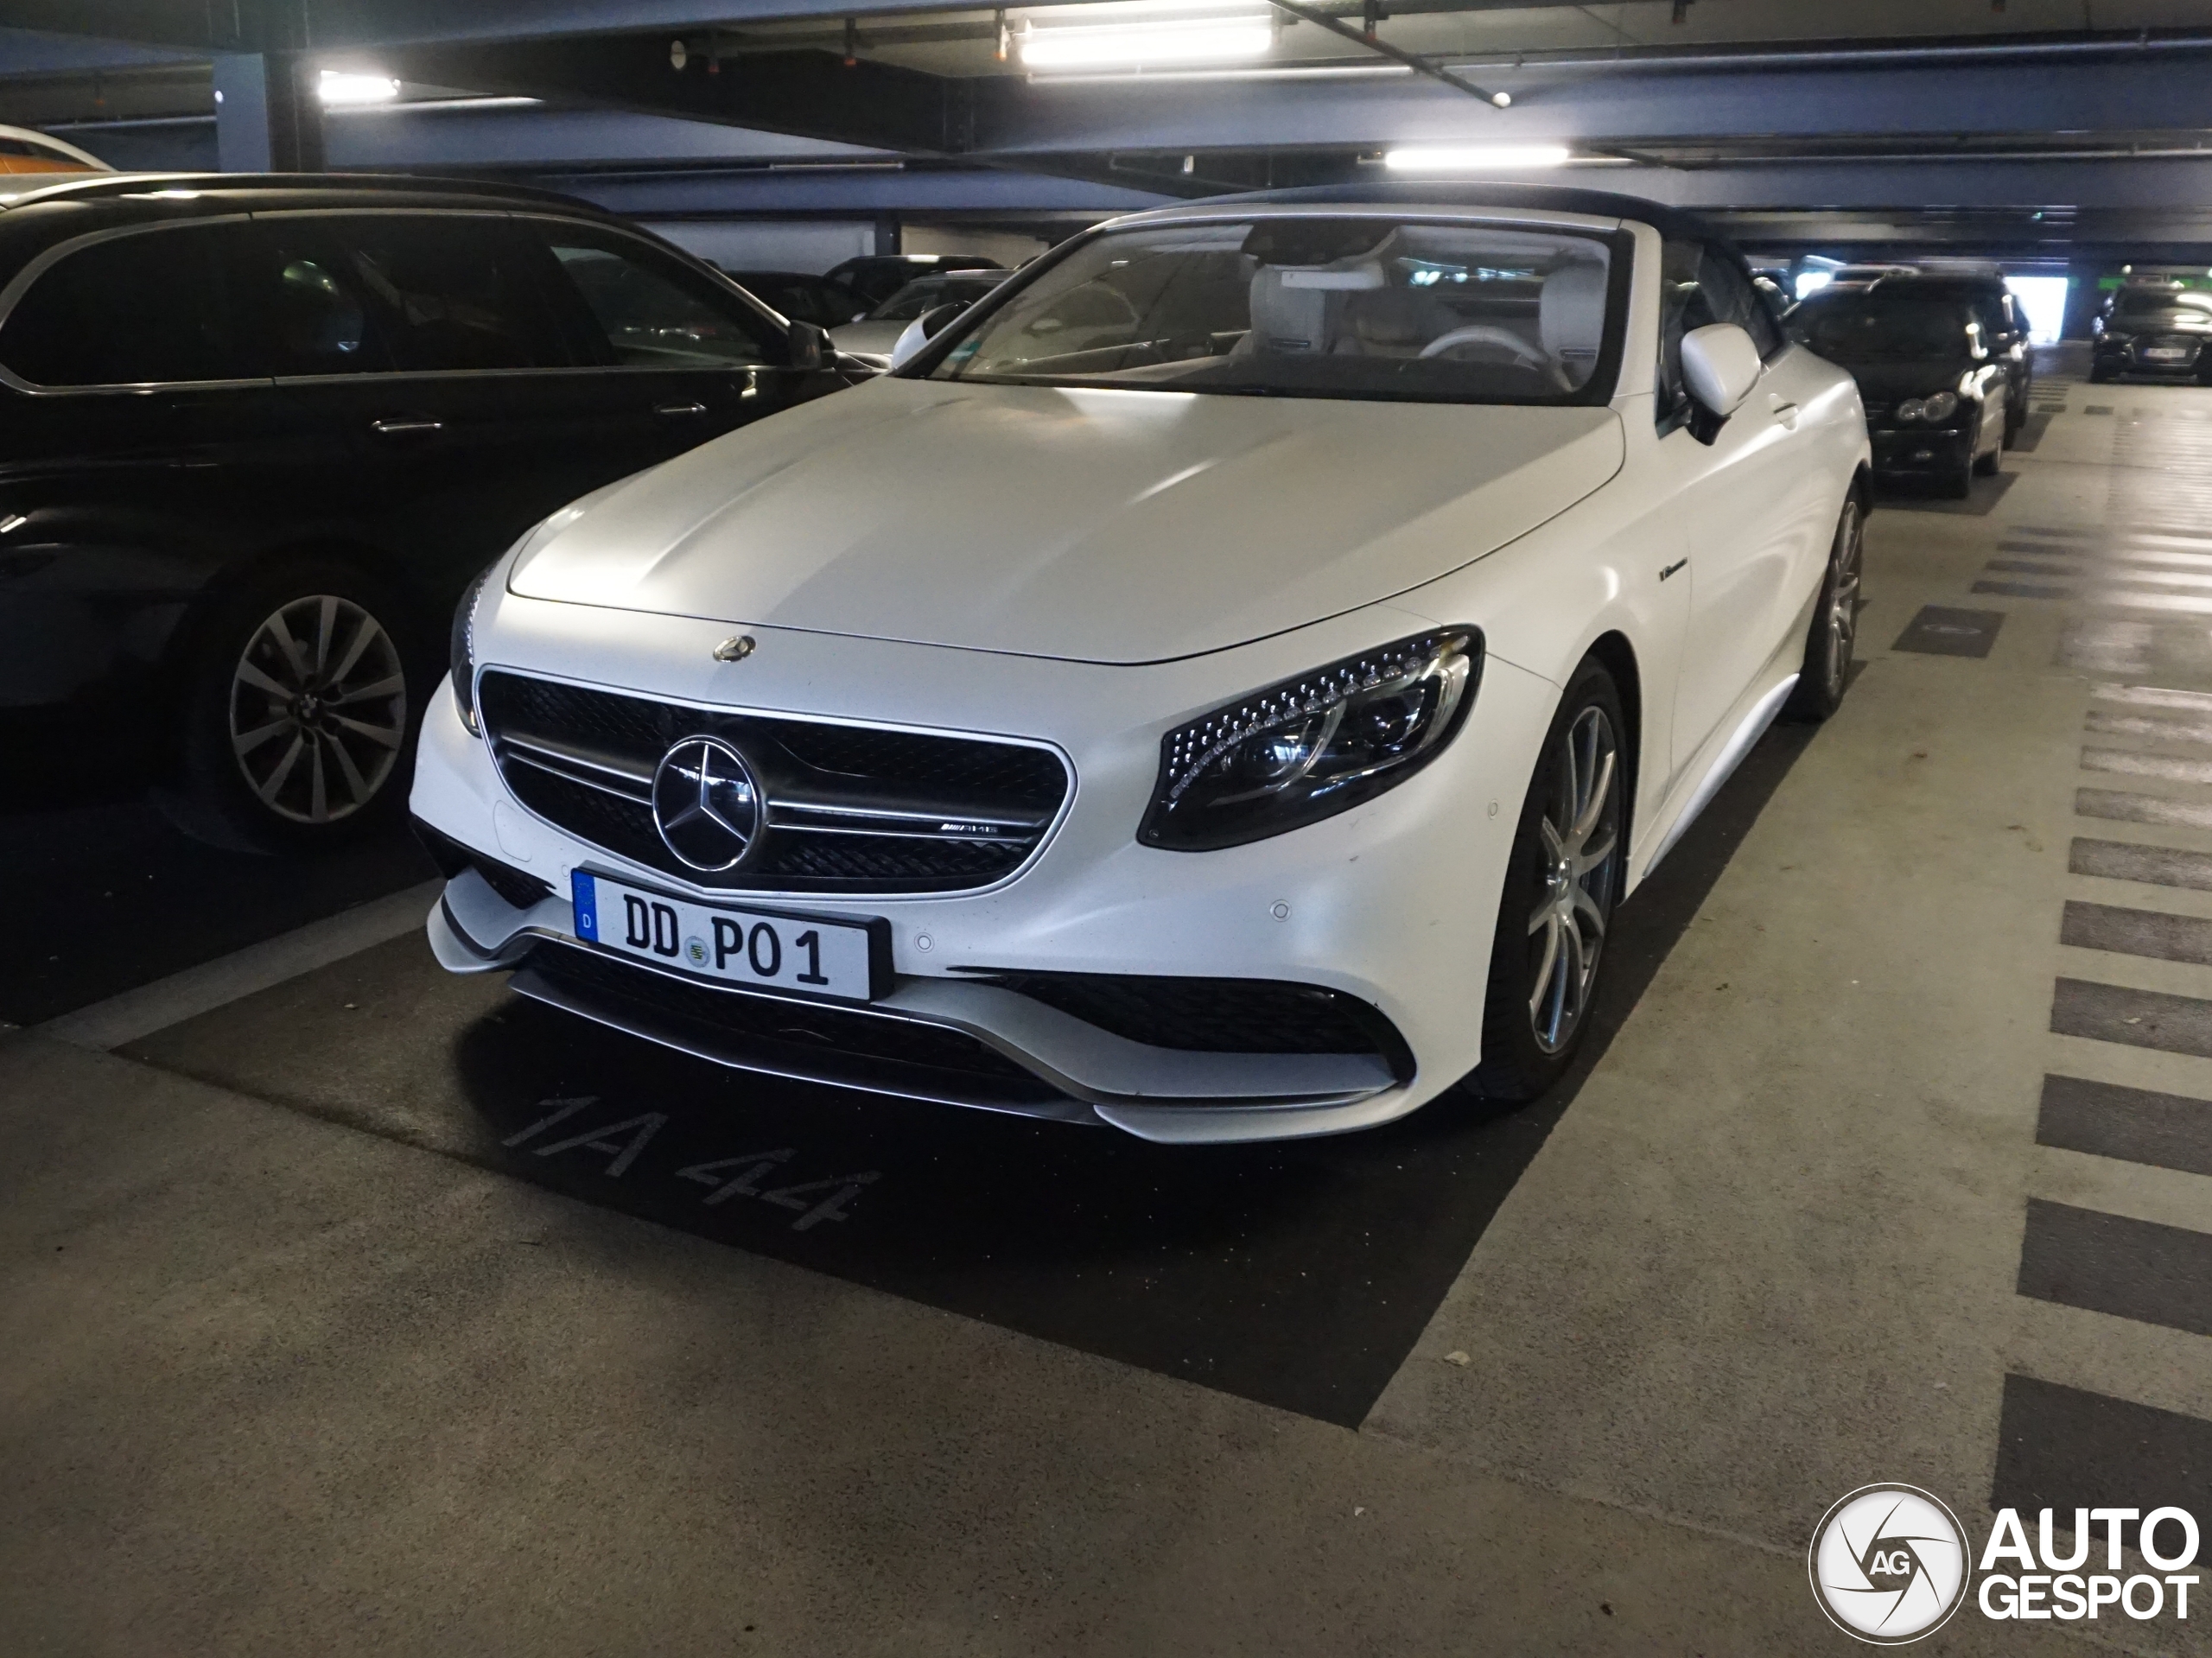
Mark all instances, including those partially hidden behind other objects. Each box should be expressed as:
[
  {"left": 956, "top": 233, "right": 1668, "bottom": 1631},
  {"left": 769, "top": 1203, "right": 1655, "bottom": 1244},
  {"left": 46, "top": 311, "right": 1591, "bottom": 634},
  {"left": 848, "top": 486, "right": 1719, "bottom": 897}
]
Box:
[{"left": 157, "top": 559, "right": 429, "bottom": 851}]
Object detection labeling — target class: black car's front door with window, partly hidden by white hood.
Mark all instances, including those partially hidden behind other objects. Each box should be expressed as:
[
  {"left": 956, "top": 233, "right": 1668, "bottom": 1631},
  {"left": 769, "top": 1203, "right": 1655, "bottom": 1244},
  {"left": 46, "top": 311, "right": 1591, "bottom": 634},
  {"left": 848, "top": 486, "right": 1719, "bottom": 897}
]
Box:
[{"left": 515, "top": 214, "right": 845, "bottom": 484}]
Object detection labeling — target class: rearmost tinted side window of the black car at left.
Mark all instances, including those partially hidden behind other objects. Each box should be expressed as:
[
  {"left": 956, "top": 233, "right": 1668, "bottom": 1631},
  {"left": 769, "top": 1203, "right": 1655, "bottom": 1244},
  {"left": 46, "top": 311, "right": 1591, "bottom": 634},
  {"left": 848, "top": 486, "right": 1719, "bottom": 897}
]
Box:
[{"left": 0, "top": 226, "right": 257, "bottom": 387}]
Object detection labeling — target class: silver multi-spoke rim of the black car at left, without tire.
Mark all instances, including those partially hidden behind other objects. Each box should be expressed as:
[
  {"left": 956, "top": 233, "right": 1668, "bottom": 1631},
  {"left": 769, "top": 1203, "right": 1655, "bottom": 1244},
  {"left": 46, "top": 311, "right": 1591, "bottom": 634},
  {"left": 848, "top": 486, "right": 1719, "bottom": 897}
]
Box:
[{"left": 230, "top": 593, "right": 407, "bottom": 823}]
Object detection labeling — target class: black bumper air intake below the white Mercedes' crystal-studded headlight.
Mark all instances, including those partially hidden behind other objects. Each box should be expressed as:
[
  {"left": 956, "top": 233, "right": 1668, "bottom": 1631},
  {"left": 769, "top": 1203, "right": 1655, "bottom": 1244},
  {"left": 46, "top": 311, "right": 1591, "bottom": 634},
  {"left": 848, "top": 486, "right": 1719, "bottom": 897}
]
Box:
[{"left": 976, "top": 973, "right": 1411, "bottom": 1077}]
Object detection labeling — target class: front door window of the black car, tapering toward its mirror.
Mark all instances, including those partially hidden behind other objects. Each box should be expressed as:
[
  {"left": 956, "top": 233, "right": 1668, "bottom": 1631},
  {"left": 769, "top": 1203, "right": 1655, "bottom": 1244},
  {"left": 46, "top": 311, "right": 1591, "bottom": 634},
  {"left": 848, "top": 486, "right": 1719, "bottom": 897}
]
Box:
[{"left": 531, "top": 221, "right": 787, "bottom": 369}]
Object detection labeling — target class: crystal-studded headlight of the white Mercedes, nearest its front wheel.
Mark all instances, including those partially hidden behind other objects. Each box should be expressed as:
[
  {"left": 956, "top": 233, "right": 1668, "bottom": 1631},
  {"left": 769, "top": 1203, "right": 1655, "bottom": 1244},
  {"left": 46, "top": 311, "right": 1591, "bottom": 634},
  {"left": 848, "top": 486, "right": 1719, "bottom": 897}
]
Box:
[{"left": 1137, "top": 628, "right": 1482, "bottom": 851}]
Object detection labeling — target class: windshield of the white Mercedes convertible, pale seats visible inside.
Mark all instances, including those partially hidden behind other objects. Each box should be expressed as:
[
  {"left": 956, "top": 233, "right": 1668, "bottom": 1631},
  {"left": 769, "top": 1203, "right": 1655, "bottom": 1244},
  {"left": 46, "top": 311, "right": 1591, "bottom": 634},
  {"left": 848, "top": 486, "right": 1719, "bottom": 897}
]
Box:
[{"left": 931, "top": 217, "right": 1619, "bottom": 404}]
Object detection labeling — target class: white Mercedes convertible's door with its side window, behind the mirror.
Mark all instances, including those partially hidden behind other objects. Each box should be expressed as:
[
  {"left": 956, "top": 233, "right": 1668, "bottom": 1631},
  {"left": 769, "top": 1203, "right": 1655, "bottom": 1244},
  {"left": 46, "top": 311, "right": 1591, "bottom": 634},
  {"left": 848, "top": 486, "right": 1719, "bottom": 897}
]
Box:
[{"left": 1659, "top": 241, "right": 1836, "bottom": 796}]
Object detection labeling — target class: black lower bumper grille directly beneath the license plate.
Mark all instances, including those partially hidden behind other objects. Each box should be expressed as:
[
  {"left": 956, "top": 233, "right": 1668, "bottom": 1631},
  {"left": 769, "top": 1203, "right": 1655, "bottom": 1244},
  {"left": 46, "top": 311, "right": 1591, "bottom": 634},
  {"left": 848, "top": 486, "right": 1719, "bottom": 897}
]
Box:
[{"left": 524, "top": 944, "right": 1062, "bottom": 1101}]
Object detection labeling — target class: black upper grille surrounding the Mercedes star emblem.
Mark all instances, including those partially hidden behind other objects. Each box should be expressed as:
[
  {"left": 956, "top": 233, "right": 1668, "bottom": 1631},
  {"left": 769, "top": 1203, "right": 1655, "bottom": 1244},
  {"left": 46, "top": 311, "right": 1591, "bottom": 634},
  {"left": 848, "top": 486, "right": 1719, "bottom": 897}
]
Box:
[{"left": 478, "top": 672, "right": 1068, "bottom": 893}]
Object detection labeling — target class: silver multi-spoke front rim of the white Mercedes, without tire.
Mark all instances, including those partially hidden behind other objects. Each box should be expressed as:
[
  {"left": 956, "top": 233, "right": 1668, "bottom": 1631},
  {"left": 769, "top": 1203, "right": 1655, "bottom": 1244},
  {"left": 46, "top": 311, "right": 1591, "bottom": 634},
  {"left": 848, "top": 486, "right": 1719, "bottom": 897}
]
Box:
[{"left": 1529, "top": 708, "right": 1621, "bottom": 1054}]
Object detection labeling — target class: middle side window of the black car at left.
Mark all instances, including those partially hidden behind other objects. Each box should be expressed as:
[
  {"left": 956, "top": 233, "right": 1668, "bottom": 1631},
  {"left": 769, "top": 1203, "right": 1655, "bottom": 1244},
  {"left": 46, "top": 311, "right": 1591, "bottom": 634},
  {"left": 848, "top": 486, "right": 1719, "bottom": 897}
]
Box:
[{"left": 296, "top": 213, "right": 570, "bottom": 373}]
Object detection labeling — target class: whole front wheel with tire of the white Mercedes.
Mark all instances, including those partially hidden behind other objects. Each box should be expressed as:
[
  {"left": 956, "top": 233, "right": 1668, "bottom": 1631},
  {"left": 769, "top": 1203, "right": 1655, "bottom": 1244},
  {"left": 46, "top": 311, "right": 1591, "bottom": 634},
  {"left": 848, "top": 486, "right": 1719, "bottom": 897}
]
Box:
[{"left": 1466, "top": 657, "right": 1628, "bottom": 1101}]
